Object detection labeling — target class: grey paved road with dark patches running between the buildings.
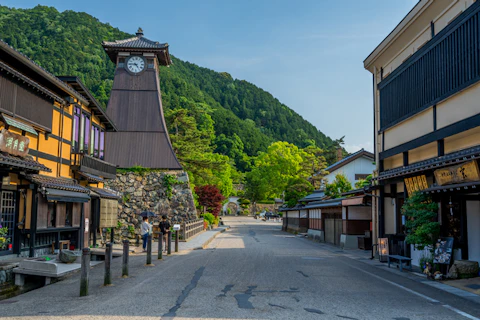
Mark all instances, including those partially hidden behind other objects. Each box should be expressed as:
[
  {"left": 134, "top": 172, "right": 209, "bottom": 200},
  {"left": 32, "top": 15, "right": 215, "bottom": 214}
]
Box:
[{"left": 0, "top": 218, "right": 480, "bottom": 320}]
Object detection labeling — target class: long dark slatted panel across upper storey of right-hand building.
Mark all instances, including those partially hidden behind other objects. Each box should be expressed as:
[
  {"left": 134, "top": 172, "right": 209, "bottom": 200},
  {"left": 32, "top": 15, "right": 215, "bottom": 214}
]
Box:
[{"left": 378, "top": 2, "right": 480, "bottom": 130}]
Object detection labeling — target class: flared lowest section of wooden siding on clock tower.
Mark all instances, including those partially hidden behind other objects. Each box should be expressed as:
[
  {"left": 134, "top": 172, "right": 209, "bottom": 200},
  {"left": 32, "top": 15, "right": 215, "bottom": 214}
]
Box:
[{"left": 105, "top": 132, "right": 182, "bottom": 170}]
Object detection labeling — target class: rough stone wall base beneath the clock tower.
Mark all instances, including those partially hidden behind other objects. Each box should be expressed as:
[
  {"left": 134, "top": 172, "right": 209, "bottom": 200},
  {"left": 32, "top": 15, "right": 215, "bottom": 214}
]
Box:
[{"left": 105, "top": 171, "right": 197, "bottom": 240}]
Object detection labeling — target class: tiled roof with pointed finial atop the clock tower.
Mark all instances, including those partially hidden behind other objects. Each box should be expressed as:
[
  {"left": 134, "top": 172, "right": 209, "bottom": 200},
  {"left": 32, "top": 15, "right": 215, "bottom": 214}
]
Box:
[{"left": 102, "top": 28, "right": 172, "bottom": 66}]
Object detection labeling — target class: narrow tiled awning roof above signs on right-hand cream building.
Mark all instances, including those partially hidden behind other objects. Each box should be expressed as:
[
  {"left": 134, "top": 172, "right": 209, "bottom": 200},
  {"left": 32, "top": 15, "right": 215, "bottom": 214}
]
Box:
[{"left": 374, "top": 146, "right": 480, "bottom": 180}]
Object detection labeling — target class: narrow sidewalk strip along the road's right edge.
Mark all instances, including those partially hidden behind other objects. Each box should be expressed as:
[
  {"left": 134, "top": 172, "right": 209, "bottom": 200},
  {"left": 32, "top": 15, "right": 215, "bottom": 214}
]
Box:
[{"left": 300, "top": 237, "right": 480, "bottom": 304}]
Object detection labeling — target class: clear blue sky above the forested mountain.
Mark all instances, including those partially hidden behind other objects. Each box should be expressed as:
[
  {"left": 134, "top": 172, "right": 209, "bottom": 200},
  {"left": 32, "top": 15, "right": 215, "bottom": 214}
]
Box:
[{"left": 0, "top": 0, "right": 418, "bottom": 152}]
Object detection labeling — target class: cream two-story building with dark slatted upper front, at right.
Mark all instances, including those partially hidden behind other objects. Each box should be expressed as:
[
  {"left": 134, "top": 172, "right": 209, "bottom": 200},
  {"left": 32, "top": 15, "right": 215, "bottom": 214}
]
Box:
[{"left": 364, "top": 0, "right": 480, "bottom": 261}]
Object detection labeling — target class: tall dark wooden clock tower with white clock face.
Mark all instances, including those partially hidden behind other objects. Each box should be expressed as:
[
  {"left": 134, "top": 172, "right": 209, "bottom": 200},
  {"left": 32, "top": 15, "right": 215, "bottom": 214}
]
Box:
[{"left": 102, "top": 28, "right": 182, "bottom": 170}]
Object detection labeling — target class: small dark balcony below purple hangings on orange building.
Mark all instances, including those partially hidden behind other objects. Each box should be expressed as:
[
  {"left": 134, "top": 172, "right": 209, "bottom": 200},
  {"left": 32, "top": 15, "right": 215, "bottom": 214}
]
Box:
[{"left": 71, "top": 153, "right": 117, "bottom": 179}]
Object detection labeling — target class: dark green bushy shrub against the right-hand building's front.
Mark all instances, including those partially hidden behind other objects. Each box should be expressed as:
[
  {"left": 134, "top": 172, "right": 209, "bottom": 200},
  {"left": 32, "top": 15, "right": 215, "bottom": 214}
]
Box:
[{"left": 402, "top": 192, "right": 440, "bottom": 250}]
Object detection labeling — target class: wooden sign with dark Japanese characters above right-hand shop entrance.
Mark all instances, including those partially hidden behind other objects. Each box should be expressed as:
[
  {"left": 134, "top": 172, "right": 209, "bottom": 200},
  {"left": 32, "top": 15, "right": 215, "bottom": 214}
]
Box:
[{"left": 435, "top": 160, "right": 480, "bottom": 186}]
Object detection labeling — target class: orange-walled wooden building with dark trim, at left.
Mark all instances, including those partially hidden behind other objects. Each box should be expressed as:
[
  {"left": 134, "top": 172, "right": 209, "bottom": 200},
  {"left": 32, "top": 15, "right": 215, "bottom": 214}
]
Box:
[{"left": 0, "top": 41, "right": 118, "bottom": 256}]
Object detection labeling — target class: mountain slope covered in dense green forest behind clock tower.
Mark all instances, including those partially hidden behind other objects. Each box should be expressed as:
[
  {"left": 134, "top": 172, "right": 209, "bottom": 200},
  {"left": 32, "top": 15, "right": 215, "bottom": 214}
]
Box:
[{"left": 0, "top": 6, "right": 334, "bottom": 162}]
